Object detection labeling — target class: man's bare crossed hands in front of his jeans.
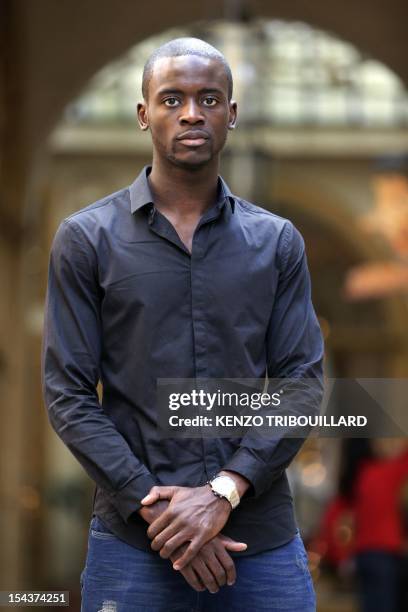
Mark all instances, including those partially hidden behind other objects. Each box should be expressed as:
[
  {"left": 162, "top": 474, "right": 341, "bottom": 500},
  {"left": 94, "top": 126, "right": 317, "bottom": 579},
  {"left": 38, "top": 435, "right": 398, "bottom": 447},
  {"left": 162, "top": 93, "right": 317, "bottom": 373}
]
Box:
[{"left": 139, "top": 485, "right": 247, "bottom": 593}]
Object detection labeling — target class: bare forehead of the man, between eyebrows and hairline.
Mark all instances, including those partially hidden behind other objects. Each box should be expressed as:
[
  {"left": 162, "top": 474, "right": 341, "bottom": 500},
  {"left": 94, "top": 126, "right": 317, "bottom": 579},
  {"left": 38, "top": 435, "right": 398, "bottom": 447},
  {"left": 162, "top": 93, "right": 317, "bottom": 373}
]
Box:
[{"left": 149, "top": 55, "right": 228, "bottom": 95}]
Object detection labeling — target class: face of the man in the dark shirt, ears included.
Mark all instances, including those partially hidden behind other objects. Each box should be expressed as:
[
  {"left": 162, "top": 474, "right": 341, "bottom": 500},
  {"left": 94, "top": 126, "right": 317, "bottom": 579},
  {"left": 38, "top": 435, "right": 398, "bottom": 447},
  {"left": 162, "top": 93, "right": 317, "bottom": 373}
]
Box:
[{"left": 138, "top": 55, "right": 236, "bottom": 169}]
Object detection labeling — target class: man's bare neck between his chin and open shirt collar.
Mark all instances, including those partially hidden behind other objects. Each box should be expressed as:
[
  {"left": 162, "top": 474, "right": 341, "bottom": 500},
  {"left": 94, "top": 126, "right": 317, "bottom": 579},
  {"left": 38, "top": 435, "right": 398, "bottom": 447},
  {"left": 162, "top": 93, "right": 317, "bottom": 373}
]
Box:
[{"left": 149, "top": 155, "right": 219, "bottom": 214}]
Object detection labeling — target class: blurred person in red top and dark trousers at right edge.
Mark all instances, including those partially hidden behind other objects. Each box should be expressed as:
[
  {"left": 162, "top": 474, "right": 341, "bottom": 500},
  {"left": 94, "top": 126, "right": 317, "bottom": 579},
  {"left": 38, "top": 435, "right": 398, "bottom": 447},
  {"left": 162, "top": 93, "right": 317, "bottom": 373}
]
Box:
[{"left": 353, "top": 438, "right": 408, "bottom": 612}]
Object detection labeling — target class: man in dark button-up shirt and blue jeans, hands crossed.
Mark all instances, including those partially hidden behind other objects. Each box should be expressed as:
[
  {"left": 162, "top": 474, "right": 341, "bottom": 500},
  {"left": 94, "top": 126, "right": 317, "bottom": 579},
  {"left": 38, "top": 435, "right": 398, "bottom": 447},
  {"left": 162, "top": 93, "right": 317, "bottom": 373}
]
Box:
[{"left": 43, "top": 38, "right": 322, "bottom": 612}]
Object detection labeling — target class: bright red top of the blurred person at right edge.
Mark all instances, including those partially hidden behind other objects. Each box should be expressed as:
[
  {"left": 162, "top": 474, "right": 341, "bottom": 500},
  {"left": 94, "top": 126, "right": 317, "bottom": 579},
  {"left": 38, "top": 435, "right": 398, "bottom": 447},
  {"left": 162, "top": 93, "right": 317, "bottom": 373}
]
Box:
[{"left": 354, "top": 451, "right": 408, "bottom": 553}]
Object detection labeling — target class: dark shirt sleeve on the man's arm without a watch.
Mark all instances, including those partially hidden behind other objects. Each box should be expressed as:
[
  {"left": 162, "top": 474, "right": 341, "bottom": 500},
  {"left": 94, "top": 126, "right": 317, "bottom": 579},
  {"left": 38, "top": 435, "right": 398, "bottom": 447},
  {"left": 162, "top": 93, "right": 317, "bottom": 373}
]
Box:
[{"left": 42, "top": 220, "right": 157, "bottom": 522}]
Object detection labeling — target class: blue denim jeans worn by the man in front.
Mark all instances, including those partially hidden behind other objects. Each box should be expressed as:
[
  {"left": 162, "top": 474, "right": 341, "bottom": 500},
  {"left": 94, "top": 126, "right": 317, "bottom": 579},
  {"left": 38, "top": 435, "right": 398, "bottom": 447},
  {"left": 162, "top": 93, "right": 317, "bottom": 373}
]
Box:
[{"left": 81, "top": 517, "right": 316, "bottom": 612}]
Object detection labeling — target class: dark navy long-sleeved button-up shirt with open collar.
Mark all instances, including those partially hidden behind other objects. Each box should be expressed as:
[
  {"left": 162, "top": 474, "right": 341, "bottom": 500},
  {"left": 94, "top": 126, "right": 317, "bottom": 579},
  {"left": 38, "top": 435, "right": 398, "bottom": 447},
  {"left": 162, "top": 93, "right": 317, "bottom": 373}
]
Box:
[{"left": 43, "top": 167, "right": 323, "bottom": 554}]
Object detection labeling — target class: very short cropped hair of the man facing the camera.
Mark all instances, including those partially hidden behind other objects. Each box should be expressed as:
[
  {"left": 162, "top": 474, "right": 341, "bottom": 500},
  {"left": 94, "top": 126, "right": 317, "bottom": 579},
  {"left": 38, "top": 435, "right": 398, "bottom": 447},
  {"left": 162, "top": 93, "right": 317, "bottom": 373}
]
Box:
[{"left": 142, "top": 37, "right": 233, "bottom": 100}]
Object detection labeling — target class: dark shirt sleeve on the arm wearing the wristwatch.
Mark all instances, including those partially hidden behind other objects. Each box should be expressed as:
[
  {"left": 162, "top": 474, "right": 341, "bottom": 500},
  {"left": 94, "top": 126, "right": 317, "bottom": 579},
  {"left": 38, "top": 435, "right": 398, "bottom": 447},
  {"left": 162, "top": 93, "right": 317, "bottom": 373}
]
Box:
[{"left": 223, "top": 222, "right": 323, "bottom": 497}]
